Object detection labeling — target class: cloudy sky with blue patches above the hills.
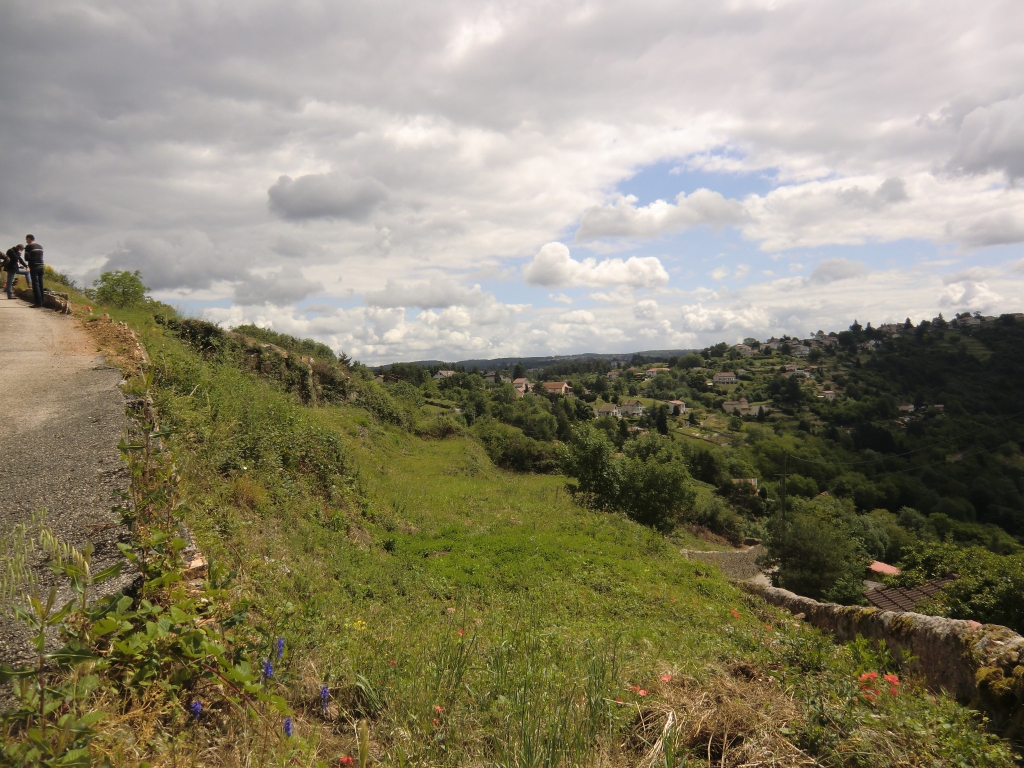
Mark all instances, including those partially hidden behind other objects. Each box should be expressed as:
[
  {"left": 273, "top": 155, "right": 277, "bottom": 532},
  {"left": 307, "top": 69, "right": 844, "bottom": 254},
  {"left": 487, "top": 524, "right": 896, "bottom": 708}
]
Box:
[{"left": 0, "top": 0, "right": 1024, "bottom": 362}]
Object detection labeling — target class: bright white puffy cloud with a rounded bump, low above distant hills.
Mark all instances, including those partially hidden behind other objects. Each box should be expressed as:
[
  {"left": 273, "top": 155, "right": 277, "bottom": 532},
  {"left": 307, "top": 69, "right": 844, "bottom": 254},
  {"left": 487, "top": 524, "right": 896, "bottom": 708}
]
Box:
[{"left": 522, "top": 243, "right": 669, "bottom": 288}]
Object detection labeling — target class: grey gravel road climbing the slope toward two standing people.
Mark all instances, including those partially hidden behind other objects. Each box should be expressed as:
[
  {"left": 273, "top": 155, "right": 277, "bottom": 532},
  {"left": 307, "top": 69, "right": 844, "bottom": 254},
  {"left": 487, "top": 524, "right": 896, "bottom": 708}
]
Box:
[{"left": 0, "top": 298, "right": 135, "bottom": 664}]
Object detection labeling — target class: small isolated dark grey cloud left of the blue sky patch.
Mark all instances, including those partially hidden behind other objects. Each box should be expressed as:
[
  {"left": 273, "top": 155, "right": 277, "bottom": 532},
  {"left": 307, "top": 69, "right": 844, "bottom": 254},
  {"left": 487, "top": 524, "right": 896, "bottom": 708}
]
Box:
[{"left": 266, "top": 173, "right": 387, "bottom": 220}]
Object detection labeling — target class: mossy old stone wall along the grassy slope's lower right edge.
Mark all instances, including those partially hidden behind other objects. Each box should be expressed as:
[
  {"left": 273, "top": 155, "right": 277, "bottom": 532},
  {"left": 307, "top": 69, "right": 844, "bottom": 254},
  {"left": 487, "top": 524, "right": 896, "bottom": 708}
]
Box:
[{"left": 740, "top": 582, "right": 1024, "bottom": 727}]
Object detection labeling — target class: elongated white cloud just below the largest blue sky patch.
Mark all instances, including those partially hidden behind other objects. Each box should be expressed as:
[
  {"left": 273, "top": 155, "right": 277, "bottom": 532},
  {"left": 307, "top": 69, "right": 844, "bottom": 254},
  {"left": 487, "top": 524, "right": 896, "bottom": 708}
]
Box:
[{"left": 575, "top": 189, "right": 745, "bottom": 241}]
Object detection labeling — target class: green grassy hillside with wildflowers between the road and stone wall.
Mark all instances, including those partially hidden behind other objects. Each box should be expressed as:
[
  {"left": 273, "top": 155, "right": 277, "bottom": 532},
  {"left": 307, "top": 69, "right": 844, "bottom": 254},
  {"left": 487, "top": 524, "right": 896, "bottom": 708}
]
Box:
[{"left": 2, "top": 274, "right": 1012, "bottom": 768}]
